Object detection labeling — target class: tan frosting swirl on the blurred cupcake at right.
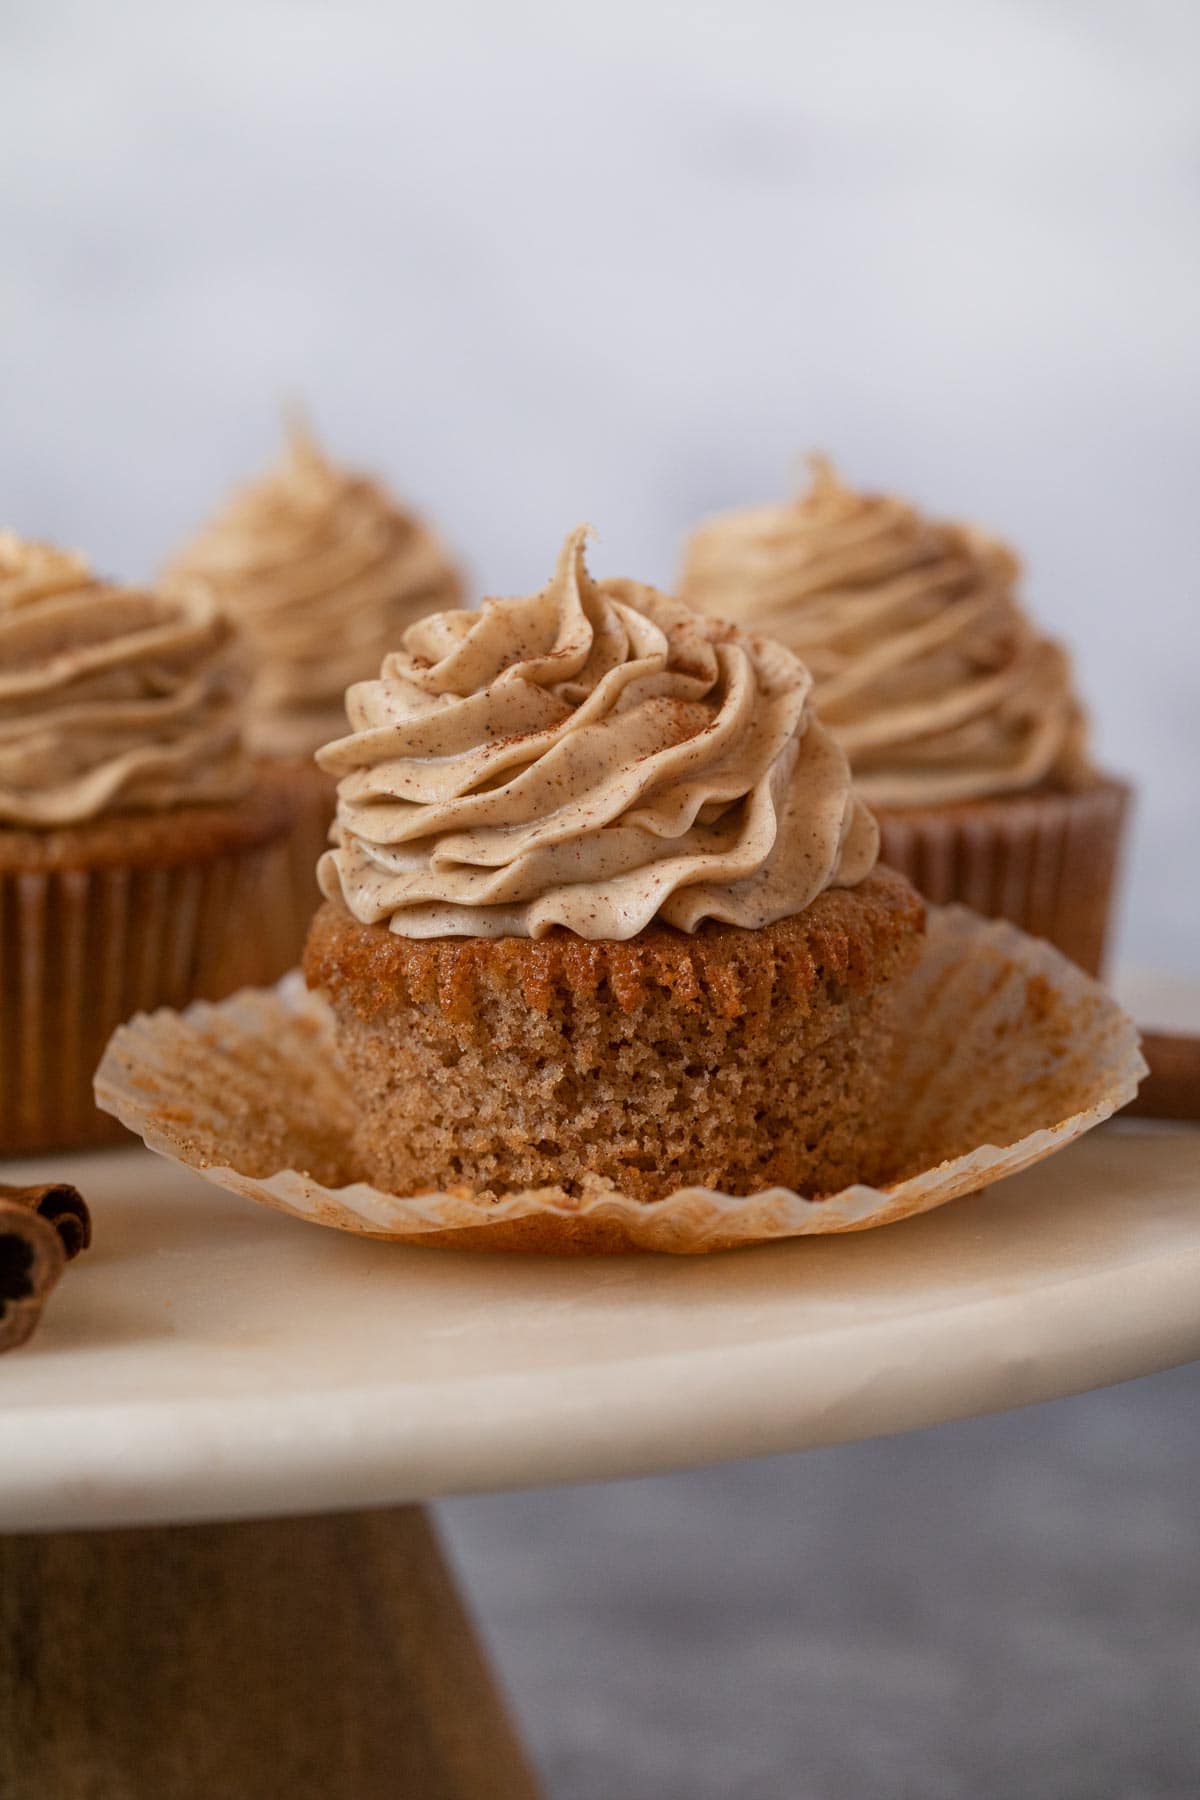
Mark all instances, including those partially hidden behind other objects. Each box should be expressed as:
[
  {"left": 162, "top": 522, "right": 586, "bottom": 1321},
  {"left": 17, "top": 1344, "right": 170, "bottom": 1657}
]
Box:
[{"left": 684, "top": 457, "right": 1090, "bottom": 806}]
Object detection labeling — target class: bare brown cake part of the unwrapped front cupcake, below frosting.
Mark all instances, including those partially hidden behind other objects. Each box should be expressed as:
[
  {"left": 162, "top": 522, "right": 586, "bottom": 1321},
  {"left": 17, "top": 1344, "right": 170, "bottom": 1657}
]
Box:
[{"left": 306, "top": 869, "right": 923, "bottom": 1201}]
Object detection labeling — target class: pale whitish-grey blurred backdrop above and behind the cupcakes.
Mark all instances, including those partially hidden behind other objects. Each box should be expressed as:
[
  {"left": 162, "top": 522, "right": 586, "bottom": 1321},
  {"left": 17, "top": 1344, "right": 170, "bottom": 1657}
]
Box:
[{"left": 0, "top": 0, "right": 1200, "bottom": 970}]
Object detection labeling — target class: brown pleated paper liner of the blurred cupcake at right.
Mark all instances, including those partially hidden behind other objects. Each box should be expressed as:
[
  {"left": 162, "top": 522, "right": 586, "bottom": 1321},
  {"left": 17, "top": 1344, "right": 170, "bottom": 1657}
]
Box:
[{"left": 876, "top": 778, "right": 1132, "bottom": 976}]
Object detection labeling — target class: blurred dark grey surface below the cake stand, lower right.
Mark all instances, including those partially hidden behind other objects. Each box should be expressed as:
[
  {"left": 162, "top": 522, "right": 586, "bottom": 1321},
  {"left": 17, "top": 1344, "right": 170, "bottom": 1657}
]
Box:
[{"left": 441, "top": 1360, "right": 1200, "bottom": 1800}]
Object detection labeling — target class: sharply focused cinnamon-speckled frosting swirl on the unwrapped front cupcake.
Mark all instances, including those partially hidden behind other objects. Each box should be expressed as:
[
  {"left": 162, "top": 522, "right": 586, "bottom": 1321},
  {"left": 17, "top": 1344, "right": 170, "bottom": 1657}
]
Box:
[{"left": 317, "top": 527, "right": 878, "bottom": 940}]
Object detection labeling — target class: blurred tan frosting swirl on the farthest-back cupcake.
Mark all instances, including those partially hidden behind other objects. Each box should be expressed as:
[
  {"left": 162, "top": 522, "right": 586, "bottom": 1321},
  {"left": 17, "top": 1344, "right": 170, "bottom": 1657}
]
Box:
[{"left": 173, "top": 427, "right": 461, "bottom": 758}]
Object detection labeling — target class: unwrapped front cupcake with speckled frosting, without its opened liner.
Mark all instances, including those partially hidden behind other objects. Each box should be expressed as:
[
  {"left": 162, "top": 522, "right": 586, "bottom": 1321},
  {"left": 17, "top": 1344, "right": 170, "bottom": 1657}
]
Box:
[{"left": 304, "top": 529, "right": 923, "bottom": 1202}]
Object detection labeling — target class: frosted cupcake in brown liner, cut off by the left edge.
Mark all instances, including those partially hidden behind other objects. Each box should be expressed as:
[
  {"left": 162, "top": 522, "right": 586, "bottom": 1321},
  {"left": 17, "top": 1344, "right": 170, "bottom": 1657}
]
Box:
[{"left": 0, "top": 533, "right": 291, "bottom": 1154}]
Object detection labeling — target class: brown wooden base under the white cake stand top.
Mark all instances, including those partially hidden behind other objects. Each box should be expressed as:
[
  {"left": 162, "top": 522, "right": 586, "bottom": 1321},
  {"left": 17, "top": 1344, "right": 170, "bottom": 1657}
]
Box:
[{"left": 0, "top": 1507, "right": 536, "bottom": 1800}]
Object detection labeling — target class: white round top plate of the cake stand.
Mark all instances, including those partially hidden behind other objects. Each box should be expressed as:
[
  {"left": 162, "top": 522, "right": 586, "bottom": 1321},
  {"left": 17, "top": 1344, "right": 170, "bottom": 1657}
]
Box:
[{"left": 0, "top": 1125, "right": 1200, "bottom": 1530}]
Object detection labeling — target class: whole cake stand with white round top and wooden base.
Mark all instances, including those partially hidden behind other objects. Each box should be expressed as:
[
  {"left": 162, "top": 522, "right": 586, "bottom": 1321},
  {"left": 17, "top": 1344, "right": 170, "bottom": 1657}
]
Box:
[{"left": 0, "top": 992, "right": 1200, "bottom": 1800}]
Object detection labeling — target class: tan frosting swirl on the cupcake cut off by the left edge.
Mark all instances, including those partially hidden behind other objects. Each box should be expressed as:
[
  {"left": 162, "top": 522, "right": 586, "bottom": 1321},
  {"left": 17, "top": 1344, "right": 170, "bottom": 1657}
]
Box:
[{"left": 0, "top": 531, "right": 250, "bottom": 830}]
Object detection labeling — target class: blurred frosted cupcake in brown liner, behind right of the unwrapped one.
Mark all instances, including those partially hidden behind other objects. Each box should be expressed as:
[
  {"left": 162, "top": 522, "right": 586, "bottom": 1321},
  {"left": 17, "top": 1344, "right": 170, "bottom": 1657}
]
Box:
[{"left": 682, "top": 457, "right": 1130, "bottom": 974}]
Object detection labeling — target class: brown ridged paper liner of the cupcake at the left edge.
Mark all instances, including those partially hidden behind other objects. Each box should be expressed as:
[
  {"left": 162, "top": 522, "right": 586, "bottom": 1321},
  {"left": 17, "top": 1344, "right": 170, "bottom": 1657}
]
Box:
[{"left": 0, "top": 841, "right": 296, "bottom": 1156}]
